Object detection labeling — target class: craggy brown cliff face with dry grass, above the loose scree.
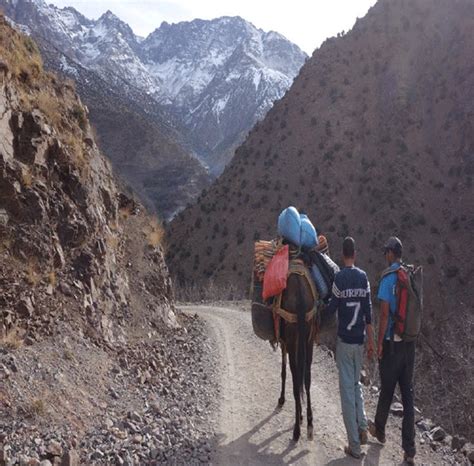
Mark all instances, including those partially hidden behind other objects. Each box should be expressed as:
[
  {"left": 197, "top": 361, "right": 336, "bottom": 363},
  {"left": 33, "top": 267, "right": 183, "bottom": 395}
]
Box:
[{"left": 0, "top": 18, "right": 175, "bottom": 345}]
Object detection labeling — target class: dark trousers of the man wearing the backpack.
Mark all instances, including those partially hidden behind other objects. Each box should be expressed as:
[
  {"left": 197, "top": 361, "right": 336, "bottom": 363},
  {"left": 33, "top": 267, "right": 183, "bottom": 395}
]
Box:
[{"left": 375, "top": 340, "right": 416, "bottom": 456}]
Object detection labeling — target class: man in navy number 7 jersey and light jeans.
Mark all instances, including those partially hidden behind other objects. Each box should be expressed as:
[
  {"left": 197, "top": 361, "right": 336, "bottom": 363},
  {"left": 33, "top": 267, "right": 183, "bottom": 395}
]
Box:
[{"left": 328, "top": 237, "right": 374, "bottom": 459}]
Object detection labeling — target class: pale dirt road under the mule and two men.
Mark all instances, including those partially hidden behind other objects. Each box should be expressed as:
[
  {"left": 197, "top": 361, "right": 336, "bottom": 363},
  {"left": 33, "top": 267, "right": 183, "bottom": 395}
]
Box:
[{"left": 183, "top": 306, "right": 456, "bottom": 466}]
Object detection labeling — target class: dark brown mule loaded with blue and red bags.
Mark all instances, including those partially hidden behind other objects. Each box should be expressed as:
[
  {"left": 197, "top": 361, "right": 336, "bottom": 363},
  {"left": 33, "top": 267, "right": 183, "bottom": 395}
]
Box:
[{"left": 251, "top": 207, "right": 338, "bottom": 441}]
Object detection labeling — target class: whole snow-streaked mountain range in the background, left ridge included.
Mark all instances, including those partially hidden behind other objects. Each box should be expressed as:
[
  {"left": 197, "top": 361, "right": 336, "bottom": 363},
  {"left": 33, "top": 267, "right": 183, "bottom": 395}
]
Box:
[{"left": 0, "top": 0, "right": 306, "bottom": 176}]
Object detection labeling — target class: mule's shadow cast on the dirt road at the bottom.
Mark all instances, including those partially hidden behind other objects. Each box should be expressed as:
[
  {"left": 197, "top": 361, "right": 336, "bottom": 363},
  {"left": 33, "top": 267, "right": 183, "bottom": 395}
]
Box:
[{"left": 215, "top": 409, "right": 309, "bottom": 465}]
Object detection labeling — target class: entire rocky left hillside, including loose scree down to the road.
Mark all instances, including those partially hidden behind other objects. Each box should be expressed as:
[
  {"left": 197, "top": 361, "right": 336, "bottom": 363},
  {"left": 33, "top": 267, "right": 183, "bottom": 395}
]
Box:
[{"left": 0, "top": 16, "right": 218, "bottom": 465}]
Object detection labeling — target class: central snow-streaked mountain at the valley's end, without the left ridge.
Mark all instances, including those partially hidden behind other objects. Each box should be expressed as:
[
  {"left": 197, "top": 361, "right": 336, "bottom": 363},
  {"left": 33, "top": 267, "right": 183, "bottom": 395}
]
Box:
[{"left": 142, "top": 17, "right": 305, "bottom": 173}]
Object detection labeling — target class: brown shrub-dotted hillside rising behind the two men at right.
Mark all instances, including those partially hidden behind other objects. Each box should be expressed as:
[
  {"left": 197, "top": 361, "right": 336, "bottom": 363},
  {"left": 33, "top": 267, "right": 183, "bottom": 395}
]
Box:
[{"left": 168, "top": 0, "right": 474, "bottom": 436}]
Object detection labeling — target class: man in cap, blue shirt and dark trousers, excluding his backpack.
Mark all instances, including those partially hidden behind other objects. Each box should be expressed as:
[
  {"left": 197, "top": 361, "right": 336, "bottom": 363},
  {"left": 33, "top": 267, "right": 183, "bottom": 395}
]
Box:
[{"left": 369, "top": 236, "right": 416, "bottom": 464}]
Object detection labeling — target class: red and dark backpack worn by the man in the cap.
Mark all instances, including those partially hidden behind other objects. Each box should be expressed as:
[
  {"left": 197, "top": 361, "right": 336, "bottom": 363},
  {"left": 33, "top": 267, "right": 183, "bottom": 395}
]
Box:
[{"left": 382, "top": 264, "right": 423, "bottom": 342}]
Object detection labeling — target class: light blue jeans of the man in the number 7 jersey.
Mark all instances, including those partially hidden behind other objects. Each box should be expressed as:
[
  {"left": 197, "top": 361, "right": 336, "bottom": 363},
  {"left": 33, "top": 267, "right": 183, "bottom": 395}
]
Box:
[{"left": 336, "top": 338, "right": 367, "bottom": 454}]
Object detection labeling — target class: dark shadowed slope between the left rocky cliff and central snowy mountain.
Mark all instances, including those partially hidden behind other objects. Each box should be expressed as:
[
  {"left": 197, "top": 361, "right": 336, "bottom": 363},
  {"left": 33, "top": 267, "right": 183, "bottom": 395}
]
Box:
[{"left": 33, "top": 33, "right": 211, "bottom": 219}]
